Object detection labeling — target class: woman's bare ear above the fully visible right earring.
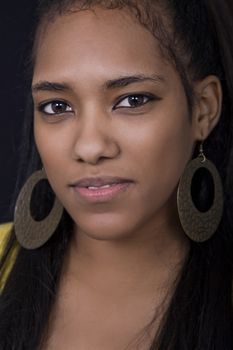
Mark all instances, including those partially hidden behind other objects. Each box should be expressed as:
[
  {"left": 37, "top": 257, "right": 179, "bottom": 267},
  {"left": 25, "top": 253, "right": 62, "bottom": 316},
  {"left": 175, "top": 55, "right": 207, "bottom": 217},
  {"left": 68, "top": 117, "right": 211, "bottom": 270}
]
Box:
[{"left": 192, "top": 75, "right": 222, "bottom": 141}]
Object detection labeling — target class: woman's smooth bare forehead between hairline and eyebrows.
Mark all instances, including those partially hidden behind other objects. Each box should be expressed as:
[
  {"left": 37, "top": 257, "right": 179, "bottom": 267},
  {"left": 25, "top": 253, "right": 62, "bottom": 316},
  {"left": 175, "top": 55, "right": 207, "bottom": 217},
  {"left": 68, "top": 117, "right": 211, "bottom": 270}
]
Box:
[{"left": 34, "top": 8, "right": 171, "bottom": 83}]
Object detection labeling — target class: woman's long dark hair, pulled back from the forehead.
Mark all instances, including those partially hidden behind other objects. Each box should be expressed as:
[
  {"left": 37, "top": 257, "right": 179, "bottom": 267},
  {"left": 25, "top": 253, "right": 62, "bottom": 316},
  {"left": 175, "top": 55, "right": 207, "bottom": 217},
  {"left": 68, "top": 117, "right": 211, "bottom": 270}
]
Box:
[{"left": 0, "top": 0, "right": 233, "bottom": 350}]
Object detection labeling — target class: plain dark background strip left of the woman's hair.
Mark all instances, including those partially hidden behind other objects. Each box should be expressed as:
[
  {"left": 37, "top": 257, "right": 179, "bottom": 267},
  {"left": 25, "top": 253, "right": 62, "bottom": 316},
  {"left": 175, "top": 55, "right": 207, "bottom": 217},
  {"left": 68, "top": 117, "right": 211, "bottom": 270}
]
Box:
[{"left": 0, "top": 0, "right": 36, "bottom": 223}]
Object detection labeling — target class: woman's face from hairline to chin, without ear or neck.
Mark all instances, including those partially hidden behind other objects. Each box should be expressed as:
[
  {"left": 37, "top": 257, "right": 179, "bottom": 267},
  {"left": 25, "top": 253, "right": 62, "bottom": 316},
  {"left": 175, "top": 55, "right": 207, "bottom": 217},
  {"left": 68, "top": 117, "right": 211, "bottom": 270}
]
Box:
[{"left": 33, "top": 9, "right": 195, "bottom": 239}]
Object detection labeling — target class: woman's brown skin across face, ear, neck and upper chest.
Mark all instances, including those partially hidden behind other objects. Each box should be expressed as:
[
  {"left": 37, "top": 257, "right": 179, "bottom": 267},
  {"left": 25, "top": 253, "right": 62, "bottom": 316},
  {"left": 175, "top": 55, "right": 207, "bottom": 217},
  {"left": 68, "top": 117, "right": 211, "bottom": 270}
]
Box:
[{"left": 33, "top": 8, "right": 222, "bottom": 350}]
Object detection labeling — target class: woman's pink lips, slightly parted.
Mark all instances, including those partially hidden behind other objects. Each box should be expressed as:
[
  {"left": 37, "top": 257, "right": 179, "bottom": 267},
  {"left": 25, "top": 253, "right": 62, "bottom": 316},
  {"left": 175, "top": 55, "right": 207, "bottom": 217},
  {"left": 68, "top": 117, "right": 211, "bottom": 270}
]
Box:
[{"left": 72, "top": 176, "right": 133, "bottom": 203}]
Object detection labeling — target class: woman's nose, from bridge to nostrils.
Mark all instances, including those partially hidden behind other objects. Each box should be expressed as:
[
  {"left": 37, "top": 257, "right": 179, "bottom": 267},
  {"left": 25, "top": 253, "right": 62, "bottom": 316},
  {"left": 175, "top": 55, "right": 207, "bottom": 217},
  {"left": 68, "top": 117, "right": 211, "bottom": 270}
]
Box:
[{"left": 73, "top": 113, "right": 120, "bottom": 165}]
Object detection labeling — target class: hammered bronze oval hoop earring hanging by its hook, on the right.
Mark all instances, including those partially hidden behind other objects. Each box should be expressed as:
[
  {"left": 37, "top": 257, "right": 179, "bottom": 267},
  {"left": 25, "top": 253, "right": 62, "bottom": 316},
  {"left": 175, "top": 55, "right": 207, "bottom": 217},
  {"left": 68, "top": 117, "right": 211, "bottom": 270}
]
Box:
[{"left": 177, "top": 143, "right": 223, "bottom": 242}]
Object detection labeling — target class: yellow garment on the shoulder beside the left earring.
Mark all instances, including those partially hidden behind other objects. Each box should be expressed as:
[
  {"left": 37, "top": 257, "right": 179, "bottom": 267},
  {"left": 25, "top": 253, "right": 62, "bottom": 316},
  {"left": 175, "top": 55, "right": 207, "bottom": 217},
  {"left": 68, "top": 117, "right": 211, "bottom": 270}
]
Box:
[{"left": 0, "top": 223, "right": 20, "bottom": 293}]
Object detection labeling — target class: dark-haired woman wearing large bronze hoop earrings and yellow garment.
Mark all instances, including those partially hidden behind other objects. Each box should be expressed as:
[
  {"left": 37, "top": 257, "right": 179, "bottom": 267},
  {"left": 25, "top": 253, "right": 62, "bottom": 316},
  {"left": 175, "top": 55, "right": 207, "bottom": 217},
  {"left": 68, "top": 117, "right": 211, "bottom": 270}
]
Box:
[{"left": 0, "top": 0, "right": 233, "bottom": 350}]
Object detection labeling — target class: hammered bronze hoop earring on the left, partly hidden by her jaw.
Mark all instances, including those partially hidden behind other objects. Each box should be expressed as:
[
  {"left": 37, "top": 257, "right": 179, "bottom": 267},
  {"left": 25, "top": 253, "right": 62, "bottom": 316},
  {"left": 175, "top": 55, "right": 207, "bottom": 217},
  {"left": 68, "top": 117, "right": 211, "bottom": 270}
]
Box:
[{"left": 14, "top": 169, "right": 63, "bottom": 249}]
